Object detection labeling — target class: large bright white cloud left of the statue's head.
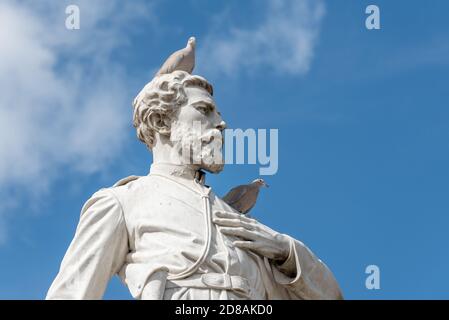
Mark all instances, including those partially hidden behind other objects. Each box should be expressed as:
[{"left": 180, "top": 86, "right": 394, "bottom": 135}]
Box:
[{"left": 0, "top": 0, "right": 154, "bottom": 239}]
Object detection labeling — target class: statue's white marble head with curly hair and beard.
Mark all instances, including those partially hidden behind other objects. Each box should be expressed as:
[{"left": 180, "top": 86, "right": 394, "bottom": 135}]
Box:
[{"left": 133, "top": 70, "right": 226, "bottom": 172}]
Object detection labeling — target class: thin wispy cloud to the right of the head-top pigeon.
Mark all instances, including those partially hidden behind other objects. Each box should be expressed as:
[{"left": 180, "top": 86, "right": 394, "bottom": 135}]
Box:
[{"left": 199, "top": 0, "right": 325, "bottom": 75}]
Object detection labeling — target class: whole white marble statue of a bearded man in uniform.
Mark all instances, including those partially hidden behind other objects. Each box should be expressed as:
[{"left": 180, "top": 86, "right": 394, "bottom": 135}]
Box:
[{"left": 46, "top": 40, "right": 342, "bottom": 300}]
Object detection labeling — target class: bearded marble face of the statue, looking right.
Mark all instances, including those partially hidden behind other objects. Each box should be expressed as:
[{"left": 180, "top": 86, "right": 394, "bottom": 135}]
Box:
[{"left": 170, "top": 87, "right": 226, "bottom": 173}]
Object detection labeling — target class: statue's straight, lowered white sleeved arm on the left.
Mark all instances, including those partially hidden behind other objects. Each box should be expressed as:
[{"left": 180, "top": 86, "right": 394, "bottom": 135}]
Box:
[{"left": 46, "top": 189, "right": 128, "bottom": 299}]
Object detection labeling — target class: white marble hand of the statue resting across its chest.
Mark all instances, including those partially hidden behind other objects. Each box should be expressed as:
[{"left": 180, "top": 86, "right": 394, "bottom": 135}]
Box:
[{"left": 213, "top": 211, "right": 290, "bottom": 261}]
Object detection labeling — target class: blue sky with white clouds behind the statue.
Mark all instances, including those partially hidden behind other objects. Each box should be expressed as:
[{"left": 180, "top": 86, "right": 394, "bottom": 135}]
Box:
[{"left": 0, "top": 0, "right": 449, "bottom": 299}]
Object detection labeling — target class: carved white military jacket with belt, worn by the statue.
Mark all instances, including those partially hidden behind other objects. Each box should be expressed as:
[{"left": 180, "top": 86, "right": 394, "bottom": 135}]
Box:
[{"left": 47, "top": 164, "right": 342, "bottom": 300}]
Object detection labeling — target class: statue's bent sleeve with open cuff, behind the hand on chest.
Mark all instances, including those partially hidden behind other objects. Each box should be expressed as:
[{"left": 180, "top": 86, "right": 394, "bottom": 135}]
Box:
[{"left": 272, "top": 236, "right": 343, "bottom": 300}]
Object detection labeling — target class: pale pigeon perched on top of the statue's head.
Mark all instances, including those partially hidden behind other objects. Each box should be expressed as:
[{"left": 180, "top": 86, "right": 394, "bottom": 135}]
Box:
[{"left": 156, "top": 37, "right": 195, "bottom": 76}]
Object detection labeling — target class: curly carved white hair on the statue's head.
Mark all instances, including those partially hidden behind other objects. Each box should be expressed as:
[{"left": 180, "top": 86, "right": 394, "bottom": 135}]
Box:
[{"left": 133, "top": 71, "right": 213, "bottom": 150}]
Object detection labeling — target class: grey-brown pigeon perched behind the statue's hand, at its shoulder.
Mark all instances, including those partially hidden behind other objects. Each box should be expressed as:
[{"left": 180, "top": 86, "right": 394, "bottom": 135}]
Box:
[{"left": 223, "top": 179, "right": 268, "bottom": 214}]
